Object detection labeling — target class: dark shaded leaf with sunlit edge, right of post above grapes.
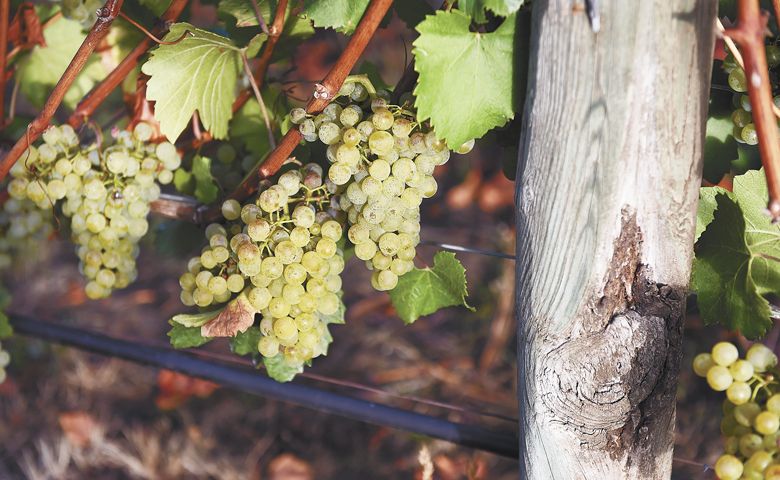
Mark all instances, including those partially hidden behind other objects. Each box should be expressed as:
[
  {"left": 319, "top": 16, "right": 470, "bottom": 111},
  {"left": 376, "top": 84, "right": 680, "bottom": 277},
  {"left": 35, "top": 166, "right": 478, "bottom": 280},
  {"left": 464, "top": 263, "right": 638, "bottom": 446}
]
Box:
[{"left": 691, "top": 171, "right": 780, "bottom": 338}]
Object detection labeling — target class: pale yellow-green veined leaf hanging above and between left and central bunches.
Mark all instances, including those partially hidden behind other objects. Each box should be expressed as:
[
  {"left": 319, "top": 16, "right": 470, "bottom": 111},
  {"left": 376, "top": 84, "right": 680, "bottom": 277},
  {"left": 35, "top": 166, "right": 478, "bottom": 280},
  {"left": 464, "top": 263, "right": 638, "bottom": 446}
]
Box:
[{"left": 141, "top": 23, "right": 242, "bottom": 142}]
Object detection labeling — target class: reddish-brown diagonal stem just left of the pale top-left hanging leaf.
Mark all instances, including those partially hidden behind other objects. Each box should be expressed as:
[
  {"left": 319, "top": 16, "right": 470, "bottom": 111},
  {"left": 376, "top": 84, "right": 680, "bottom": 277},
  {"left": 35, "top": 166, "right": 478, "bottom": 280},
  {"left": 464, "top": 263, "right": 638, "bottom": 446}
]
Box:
[{"left": 68, "top": 0, "right": 188, "bottom": 128}]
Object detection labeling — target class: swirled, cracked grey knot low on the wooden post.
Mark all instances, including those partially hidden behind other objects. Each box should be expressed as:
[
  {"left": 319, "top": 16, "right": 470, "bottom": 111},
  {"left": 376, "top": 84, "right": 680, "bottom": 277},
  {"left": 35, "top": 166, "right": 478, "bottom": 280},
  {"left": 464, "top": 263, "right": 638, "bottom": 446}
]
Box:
[{"left": 537, "top": 311, "right": 667, "bottom": 448}]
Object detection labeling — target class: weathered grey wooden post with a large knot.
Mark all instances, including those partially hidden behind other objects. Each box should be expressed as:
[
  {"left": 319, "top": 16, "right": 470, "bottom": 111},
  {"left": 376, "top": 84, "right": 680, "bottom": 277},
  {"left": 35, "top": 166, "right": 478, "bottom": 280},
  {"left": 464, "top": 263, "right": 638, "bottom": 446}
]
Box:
[{"left": 516, "top": 0, "right": 717, "bottom": 480}]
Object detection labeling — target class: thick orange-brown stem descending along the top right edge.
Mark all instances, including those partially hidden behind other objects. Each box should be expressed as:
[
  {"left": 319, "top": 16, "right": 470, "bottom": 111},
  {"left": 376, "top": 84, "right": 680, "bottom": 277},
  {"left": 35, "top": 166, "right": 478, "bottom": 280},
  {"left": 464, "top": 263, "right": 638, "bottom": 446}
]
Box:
[{"left": 725, "top": 0, "right": 780, "bottom": 222}]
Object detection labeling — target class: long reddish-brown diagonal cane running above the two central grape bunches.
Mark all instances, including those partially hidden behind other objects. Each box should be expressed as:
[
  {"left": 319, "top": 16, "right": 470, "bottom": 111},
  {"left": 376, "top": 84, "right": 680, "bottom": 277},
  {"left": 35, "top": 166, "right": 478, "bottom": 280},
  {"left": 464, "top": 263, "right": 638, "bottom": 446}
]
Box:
[{"left": 197, "top": 0, "right": 393, "bottom": 222}]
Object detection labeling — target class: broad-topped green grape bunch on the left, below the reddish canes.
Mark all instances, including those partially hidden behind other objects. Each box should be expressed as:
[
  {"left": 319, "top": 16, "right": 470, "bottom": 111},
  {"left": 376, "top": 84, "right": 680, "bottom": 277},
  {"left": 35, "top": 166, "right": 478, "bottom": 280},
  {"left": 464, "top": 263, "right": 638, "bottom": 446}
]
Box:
[{"left": 8, "top": 123, "right": 181, "bottom": 299}]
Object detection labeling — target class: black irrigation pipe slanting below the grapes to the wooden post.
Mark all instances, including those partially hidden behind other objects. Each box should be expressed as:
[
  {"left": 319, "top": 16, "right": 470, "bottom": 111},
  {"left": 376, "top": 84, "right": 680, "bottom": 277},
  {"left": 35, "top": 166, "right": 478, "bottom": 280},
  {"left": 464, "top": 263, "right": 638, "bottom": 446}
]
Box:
[{"left": 11, "top": 315, "right": 519, "bottom": 459}]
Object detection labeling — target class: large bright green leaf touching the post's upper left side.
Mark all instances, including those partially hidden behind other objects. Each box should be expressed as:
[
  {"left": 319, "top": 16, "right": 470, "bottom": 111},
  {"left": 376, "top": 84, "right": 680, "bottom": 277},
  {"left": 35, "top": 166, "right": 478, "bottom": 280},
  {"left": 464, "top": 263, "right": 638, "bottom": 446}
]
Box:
[{"left": 412, "top": 10, "right": 515, "bottom": 149}]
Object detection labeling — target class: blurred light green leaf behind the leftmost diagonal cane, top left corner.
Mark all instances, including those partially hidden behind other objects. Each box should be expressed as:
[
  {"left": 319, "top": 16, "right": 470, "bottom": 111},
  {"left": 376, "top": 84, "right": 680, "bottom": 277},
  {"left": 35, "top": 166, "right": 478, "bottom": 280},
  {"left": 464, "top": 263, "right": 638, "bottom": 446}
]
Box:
[{"left": 15, "top": 18, "right": 105, "bottom": 109}]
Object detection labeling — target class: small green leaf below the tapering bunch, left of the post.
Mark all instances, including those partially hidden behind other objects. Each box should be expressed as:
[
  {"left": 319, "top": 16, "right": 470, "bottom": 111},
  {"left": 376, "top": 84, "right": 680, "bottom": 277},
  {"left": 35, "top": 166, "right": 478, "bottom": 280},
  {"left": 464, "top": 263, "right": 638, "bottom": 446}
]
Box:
[{"left": 390, "top": 252, "right": 473, "bottom": 324}]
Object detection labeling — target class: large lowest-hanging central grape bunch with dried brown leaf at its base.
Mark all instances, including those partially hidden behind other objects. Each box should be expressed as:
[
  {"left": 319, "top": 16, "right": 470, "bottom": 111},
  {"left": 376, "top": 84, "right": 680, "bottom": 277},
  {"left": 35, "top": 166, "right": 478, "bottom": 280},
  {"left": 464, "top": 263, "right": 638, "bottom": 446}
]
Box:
[{"left": 179, "top": 164, "right": 344, "bottom": 364}]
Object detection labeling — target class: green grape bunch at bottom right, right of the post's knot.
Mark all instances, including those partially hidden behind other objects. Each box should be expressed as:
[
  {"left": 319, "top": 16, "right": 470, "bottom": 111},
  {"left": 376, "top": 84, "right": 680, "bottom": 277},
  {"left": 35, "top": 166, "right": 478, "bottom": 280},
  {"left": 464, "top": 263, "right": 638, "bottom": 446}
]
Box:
[{"left": 693, "top": 342, "right": 780, "bottom": 480}]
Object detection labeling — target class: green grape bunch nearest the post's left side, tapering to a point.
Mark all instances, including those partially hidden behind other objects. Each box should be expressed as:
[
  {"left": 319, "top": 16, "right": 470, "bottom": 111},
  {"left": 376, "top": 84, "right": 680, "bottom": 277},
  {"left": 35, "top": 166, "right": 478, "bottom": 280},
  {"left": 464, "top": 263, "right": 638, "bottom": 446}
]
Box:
[{"left": 290, "top": 83, "right": 473, "bottom": 291}]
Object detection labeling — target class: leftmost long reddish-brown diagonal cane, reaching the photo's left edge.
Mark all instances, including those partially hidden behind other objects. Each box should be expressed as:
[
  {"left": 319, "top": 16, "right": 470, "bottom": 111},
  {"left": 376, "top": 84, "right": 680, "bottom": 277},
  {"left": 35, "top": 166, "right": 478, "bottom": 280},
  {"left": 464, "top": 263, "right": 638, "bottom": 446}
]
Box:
[{"left": 0, "top": 0, "right": 124, "bottom": 181}]
